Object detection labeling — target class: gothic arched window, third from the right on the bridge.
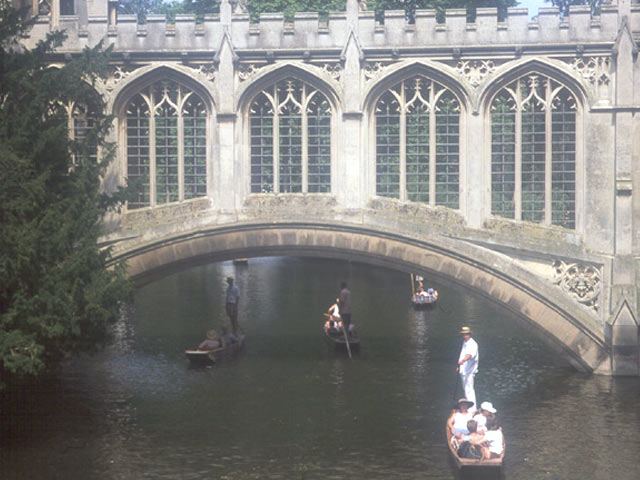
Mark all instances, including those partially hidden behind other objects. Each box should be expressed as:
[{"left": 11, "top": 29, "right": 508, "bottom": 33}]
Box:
[{"left": 249, "top": 78, "right": 332, "bottom": 193}]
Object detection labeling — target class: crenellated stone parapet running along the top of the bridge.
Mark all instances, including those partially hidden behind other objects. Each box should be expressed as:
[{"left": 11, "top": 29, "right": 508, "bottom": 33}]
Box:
[{"left": 24, "top": 5, "right": 628, "bottom": 55}]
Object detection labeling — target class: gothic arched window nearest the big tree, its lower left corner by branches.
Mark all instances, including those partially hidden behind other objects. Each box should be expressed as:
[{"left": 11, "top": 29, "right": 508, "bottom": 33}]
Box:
[{"left": 126, "top": 81, "right": 207, "bottom": 209}]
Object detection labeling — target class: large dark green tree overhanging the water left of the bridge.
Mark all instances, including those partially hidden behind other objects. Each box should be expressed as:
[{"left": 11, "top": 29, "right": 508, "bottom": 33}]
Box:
[{"left": 0, "top": 1, "right": 129, "bottom": 389}]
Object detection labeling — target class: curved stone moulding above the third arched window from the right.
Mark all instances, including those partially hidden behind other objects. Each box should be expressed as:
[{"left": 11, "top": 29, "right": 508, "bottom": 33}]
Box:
[{"left": 236, "top": 63, "right": 343, "bottom": 116}]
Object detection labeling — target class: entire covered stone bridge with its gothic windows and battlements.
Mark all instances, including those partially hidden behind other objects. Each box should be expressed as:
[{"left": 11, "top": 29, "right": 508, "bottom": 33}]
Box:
[{"left": 16, "top": 0, "right": 640, "bottom": 375}]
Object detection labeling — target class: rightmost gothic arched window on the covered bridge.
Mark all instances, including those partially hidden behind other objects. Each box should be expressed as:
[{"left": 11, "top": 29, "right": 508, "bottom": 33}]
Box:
[{"left": 491, "top": 74, "right": 576, "bottom": 228}]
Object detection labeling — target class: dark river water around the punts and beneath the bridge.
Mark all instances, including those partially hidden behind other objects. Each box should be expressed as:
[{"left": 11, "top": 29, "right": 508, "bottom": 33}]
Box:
[{"left": 0, "top": 257, "right": 640, "bottom": 480}]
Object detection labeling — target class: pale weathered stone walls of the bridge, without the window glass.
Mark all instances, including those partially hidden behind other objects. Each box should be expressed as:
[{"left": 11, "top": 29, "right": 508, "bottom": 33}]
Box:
[{"left": 18, "top": 0, "right": 640, "bottom": 375}]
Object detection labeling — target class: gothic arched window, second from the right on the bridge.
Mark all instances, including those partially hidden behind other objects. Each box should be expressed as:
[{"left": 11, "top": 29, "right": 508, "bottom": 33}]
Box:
[{"left": 375, "top": 76, "right": 460, "bottom": 209}]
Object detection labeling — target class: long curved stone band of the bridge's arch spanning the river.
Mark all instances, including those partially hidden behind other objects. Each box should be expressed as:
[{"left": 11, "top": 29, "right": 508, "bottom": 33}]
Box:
[{"left": 113, "top": 223, "right": 610, "bottom": 373}]
